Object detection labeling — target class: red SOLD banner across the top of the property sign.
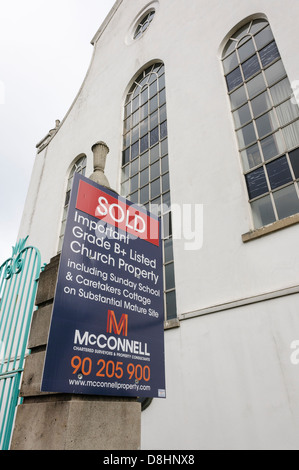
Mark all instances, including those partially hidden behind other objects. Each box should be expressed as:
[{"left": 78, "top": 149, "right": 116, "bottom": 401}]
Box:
[{"left": 76, "top": 181, "right": 159, "bottom": 246}]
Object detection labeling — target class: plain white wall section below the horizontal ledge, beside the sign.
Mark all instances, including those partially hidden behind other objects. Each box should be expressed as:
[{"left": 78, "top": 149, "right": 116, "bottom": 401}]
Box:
[{"left": 142, "top": 295, "right": 299, "bottom": 450}]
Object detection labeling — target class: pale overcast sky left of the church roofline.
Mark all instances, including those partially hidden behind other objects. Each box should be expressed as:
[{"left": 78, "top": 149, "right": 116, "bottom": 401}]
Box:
[{"left": 0, "top": 0, "right": 115, "bottom": 265}]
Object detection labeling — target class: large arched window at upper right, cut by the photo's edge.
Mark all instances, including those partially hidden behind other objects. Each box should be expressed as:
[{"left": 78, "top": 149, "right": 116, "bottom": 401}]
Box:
[{"left": 222, "top": 19, "right": 299, "bottom": 228}]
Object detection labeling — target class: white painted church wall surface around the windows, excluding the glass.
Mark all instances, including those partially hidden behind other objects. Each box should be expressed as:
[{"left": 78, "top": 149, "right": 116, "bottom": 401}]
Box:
[{"left": 19, "top": 0, "right": 299, "bottom": 448}]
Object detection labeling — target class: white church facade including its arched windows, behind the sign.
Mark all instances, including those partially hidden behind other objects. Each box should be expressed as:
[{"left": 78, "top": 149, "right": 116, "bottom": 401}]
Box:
[{"left": 19, "top": 0, "right": 299, "bottom": 449}]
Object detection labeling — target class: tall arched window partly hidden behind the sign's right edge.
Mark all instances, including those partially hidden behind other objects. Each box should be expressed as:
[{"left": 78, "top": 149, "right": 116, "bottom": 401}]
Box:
[{"left": 121, "top": 63, "right": 176, "bottom": 319}]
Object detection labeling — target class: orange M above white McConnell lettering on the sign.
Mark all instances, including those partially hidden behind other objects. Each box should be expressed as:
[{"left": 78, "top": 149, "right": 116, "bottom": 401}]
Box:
[{"left": 74, "top": 310, "right": 150, "bottom": 356}]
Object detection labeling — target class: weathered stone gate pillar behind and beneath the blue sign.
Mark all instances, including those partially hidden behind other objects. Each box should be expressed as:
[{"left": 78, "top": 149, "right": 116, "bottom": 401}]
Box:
[{"left": 11, "top": 255, "right": 141, "bottom": 450}]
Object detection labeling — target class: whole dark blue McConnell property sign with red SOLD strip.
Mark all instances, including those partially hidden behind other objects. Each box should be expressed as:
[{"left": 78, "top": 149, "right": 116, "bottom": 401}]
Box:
[{"left": 41, "top": 174, "right": 166, "bottom": 398}]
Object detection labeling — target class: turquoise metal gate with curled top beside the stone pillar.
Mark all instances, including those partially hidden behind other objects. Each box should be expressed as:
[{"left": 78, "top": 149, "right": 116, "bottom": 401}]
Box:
[{"left": 0, "top": 237, "right": 41, "bottom": 450}]
